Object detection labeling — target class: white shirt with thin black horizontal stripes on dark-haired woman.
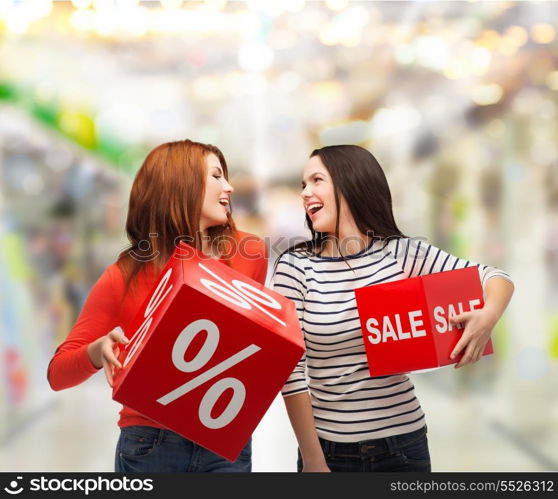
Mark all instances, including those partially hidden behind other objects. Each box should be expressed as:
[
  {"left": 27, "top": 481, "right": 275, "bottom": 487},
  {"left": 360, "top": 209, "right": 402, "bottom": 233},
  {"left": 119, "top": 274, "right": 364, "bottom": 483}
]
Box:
[{"left": 273, "top": 238, "right": 511, "bottom": 442}]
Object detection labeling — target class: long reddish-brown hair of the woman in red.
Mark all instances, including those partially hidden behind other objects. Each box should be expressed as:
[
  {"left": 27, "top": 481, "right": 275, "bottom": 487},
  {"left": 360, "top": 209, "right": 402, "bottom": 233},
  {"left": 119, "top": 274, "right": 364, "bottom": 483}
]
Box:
[{"left": 118, "top": 140, "right": 236, "bottom": 287}]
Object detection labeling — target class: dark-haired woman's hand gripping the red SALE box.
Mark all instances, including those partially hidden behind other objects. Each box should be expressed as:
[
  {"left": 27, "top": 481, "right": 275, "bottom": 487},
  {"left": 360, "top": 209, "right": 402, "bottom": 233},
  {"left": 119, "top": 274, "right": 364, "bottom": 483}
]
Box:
[{"left": 450, "top": 308, "right": 498, "bottom": 368}]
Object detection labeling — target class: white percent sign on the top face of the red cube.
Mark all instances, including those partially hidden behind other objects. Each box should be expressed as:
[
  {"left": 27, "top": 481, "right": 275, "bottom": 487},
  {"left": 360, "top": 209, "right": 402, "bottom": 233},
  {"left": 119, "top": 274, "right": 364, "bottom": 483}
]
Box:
[{"left": 198, "top": 263, "right": 287, "bottom": 327}]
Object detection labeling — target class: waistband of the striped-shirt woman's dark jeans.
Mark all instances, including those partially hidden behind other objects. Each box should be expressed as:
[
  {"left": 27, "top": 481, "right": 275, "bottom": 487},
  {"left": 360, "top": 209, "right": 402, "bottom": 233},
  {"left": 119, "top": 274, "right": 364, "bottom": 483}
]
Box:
[{"left": 320, "top": 425, "right": 427, "bottom": 454}]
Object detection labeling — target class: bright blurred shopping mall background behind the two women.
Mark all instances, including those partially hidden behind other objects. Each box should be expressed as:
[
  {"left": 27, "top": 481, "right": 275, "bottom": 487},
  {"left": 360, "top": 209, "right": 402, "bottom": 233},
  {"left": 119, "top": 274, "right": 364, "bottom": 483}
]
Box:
[{"left": 0, "top": 0, "right": 558, "bottom": 471}]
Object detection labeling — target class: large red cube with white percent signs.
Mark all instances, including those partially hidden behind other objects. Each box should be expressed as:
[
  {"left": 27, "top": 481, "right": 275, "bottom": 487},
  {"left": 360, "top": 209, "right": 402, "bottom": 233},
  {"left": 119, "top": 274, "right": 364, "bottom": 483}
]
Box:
[{"left": 113, "top": 244, "right": 304, "bottom": 461}]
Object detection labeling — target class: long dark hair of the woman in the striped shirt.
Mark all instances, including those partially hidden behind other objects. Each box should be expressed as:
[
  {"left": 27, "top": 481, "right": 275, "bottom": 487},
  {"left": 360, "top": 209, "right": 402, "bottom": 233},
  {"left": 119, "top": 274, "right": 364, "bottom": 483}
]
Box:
[{"left": 281, "top": 145, "right": 405, "bottom": 262}]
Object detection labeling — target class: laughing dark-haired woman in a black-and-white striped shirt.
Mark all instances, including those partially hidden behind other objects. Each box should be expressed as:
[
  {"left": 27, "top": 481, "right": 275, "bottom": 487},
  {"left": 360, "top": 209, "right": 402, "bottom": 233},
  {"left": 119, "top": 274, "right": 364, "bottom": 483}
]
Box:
[{"left": 274, "top": 145, "right": 513, "bottom": 471}]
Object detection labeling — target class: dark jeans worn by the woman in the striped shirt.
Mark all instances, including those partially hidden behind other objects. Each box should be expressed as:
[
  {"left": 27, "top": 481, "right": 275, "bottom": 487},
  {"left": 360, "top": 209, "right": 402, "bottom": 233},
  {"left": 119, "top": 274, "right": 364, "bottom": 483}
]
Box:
[{"left": 298, "top": 426, "right": 431, "bottom": 471}]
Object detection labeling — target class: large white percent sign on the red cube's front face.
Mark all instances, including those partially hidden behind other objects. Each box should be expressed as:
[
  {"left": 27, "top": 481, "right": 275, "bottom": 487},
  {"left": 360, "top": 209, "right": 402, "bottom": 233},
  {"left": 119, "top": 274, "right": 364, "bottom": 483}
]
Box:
[{"left": 157, "top": 319, "right": 261, "bottom": 430}]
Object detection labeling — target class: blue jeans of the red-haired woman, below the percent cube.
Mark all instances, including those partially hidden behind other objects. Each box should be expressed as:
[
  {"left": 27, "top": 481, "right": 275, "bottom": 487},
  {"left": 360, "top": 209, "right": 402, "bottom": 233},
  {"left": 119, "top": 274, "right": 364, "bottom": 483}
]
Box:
[{"left": 114, "top": 426, "right": 252, "bottom": 473}]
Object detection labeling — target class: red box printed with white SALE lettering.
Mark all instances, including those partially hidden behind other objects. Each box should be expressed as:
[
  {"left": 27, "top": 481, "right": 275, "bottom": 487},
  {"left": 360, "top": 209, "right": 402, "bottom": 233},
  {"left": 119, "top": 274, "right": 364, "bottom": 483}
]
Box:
[{"left": 355, "top": 267, "right": 493, "bottom": 376}]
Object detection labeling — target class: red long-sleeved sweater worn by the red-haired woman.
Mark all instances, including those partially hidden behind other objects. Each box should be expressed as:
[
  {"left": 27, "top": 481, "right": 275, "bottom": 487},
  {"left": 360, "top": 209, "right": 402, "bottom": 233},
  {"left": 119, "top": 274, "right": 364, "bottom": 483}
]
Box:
[{"left": 47, "top": 232, "right": 267, "bottom": 428}]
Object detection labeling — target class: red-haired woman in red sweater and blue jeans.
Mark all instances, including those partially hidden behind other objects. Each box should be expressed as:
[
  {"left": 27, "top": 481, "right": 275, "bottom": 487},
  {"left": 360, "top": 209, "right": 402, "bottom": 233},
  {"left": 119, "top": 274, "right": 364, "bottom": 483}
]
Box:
[{"left": 48, "top": 140, "right": 267, "bottom": 472}]
